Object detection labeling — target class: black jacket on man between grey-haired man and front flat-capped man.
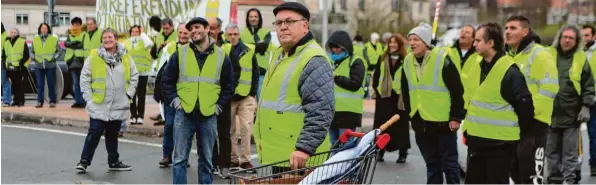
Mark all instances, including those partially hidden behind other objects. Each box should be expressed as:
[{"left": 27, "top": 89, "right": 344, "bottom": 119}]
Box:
[{"left": 230, "top": 41, "right": 259, "bottom": 101}]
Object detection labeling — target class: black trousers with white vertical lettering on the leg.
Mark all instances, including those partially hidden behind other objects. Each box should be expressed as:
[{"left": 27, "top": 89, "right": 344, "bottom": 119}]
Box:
[{"left": 511, "top": 130, "right": 546, "bottom": 184}]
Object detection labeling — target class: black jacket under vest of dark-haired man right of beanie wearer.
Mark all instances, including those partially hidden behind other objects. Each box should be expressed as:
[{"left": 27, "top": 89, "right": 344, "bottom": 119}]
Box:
[{"left": 464, "top": 52, "right": 546, "bottom": 147}]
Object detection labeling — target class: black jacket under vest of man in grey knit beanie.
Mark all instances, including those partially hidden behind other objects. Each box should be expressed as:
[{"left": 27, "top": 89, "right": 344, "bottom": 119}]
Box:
[{"left": 401, "top": 50, "right": 465, "bottom": 131}]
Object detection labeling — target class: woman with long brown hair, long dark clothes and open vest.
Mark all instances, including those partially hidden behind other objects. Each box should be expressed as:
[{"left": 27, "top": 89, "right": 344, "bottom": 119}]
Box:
[{"left": 372, "top": 34, "right": 411, "bottom": 163}]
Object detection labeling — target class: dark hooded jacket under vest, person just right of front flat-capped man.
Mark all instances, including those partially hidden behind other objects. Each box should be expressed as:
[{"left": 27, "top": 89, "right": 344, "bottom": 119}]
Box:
[{"left": 327, "top": 31, "right": 366, "bottom": 128}]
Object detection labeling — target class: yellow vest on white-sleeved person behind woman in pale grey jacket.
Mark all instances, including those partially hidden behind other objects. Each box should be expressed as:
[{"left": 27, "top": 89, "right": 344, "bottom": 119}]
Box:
[{"left": 124, "top": 39, "right": 153, "bottom": 73}]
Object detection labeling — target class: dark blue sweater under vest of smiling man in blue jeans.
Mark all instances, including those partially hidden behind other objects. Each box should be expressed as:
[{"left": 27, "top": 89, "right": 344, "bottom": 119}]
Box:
[{"left": 161, "top": 43, "right": 235, "bottom": 116}]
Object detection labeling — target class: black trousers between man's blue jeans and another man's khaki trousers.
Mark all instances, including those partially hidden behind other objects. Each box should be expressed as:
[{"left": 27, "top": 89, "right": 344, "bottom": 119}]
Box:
[{"left": 212, "top": 104, "right": 232, "bottom": 168}]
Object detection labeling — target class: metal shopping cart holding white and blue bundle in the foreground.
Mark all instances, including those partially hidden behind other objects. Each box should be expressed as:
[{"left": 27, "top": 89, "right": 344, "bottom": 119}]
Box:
[{"left": 229, "top": 115, "right": 399, "bottom": 184}]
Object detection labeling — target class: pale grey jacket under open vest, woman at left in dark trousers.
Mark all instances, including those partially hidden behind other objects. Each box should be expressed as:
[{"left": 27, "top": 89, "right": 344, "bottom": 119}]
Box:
[{"left": 81, "top": 44, "right": 139, "bottom": 121}]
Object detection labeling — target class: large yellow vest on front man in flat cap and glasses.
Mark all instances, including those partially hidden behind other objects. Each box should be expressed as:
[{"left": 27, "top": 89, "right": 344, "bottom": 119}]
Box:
[{"left": 254, "top": 40, "right": 331, "bottom": 166}]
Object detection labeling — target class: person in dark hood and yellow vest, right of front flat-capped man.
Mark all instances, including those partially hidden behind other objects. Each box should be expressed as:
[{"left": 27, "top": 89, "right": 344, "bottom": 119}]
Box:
[{"left": 326, "top": 31, "right": 366, "bottom": 145}]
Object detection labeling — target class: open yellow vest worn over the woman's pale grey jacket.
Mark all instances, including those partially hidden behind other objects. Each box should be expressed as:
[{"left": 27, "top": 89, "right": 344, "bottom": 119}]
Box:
[{"left": 89, "top": 49, "right": 131, "bottom": 104}]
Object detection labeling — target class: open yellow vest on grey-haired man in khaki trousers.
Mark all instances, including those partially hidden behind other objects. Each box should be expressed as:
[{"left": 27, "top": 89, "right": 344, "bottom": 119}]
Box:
[{"left": 222, "top": 43, "right": 255, "bottom": 96}]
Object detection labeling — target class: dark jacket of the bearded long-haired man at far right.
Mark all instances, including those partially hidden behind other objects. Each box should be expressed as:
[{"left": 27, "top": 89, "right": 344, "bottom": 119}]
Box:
[{"left": 551, "top": 26, "right": 595, "bottom": 128}]
